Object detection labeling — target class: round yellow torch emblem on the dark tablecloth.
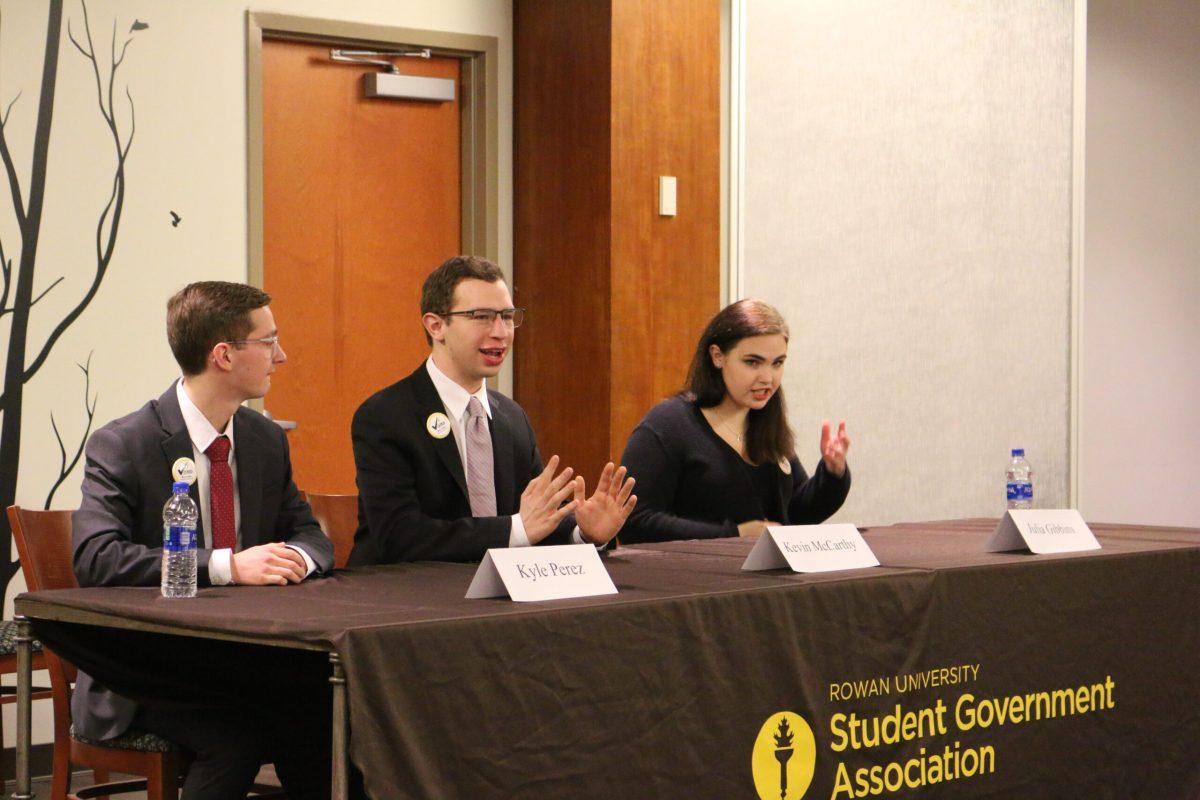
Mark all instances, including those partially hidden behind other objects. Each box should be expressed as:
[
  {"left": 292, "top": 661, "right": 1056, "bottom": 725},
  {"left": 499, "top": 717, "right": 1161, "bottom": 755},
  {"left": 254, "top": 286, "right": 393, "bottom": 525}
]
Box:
[{"left": 750, "top": 711, "right": 817, "bottom": 800}]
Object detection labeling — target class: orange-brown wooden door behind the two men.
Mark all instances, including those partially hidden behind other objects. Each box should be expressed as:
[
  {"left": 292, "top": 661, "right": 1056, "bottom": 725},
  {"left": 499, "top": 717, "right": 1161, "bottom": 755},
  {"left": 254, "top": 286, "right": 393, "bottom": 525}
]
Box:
[{"left": 263, "top": 40, "right": 462, "bottom": 493}]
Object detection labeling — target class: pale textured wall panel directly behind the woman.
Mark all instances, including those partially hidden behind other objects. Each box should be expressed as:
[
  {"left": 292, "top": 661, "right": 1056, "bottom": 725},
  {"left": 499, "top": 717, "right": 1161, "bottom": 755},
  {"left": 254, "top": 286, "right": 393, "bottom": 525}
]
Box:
[{"left": 742, "top": 0, "right": 1074, "bottom": 524}]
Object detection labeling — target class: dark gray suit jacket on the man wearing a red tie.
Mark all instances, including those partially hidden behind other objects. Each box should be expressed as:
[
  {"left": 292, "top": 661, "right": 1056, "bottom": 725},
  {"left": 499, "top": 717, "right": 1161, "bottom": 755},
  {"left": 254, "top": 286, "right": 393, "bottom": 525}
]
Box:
[{"left": 71, "top": 385, "right": 334, "bottom": 739}]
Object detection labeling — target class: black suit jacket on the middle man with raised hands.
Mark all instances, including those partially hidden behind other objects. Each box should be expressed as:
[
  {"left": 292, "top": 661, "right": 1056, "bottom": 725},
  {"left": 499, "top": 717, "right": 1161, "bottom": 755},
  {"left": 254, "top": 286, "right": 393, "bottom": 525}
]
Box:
[{"left": 349, "top": 363, "right": 575, "bottom": 566}]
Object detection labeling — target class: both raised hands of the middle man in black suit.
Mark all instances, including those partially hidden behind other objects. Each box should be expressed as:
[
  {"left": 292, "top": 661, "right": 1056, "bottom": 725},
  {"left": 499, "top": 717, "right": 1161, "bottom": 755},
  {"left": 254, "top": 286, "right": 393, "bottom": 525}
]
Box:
[{"left": 520, "top": 456, "right": 637, "bottom": 545}]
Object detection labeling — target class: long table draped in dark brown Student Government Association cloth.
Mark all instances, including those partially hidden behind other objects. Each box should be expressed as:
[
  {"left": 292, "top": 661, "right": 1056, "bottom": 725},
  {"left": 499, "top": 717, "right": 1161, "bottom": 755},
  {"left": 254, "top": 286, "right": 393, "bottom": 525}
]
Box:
[{"left": 13, "top": 519, "right": 1200, "bottom": 800}]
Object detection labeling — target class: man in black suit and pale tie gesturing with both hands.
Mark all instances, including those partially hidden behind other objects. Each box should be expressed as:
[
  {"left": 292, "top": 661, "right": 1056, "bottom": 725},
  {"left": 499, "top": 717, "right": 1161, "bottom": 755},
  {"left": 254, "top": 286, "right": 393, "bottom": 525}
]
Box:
[{"left": 349, "top": 257, "right": 637, "bottom": 566}]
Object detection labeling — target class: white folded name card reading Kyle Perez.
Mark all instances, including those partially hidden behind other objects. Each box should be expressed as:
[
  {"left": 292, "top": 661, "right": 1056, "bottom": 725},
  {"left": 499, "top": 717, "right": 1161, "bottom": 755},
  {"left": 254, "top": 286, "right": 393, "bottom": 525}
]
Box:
[{"left": 467, "top": 545, "right": 617, "bottom": 602}]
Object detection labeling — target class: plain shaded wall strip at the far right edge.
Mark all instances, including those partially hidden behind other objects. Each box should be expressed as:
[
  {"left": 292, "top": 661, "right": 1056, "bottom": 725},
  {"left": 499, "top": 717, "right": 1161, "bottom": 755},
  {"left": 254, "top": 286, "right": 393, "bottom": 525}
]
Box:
[{"left": 1080, "top": 0, "right": 1200, "bottom": 525}]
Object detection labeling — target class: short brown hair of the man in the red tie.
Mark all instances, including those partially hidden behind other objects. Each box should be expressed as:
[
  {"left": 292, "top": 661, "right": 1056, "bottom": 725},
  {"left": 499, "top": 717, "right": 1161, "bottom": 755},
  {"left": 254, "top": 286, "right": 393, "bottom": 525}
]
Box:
[{"left": 167, "top": 281, "right": 271, "bottom": 375}]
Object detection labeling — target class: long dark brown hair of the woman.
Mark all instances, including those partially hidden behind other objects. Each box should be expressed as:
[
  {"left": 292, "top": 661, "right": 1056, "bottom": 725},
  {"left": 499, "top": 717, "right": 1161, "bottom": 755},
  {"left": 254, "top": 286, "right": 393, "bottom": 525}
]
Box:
[{"left": 682, "top": 300, "right": 796, "bottom": 464}]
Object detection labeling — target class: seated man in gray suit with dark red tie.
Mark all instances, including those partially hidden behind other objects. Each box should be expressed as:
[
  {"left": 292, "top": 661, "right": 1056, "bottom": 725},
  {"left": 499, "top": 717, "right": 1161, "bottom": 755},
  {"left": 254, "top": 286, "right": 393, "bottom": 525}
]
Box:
[{"left": 72, "top": 282, "right": 334, "bottom": 800}]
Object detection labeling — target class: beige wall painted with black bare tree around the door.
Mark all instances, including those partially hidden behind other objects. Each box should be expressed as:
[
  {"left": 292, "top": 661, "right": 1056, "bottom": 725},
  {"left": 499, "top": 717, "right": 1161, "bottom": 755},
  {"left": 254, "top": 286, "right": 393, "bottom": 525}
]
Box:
[{"left": 0, "top": 0, "right": 512, "bottom": 745}]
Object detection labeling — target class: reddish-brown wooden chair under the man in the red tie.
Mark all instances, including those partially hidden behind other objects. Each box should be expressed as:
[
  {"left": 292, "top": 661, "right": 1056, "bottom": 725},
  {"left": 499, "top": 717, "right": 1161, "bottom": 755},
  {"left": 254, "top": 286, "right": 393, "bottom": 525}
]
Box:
[{"left": 8, "top": 506, "right": 188, "bottom": 800}]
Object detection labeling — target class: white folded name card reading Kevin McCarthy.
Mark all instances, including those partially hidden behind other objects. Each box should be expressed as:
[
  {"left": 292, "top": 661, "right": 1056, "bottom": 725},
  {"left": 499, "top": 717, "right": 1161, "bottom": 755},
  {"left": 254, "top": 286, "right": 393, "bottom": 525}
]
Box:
[{"left": 742, "top": 523, "right": 880, "bottom": 572}]
